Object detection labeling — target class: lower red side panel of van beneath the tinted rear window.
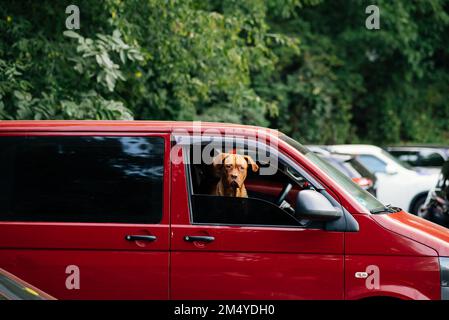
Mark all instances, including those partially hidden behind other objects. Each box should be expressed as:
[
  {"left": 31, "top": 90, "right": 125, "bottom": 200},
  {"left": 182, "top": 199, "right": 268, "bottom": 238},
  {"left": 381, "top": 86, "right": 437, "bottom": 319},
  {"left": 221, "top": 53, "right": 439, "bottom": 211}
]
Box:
[{"left": 0, "top": 249, "right": 169, "bottom": 300}]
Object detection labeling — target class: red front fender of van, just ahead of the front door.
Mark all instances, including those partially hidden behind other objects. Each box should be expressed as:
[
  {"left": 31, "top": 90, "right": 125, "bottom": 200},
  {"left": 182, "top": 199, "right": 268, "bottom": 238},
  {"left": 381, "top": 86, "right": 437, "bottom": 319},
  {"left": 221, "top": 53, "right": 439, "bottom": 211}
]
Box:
[{"left": 345, "top": 214, "right": 441, "bottom": 300}]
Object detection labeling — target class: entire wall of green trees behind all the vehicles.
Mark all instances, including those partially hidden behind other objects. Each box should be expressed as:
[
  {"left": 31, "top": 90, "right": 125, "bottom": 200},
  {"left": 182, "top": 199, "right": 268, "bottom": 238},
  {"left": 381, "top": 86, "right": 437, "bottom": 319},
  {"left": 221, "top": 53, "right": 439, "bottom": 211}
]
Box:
[{"left": 0, "top": 0, "right": 449, "bottom": 144}]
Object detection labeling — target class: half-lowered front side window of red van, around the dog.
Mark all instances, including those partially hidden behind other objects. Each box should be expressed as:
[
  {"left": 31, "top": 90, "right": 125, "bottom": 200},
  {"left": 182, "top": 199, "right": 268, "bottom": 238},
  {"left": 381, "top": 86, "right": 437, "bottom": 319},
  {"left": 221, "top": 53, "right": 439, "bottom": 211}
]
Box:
[{"left": 185, "top": 139, "right": 313, "bottom": 227}]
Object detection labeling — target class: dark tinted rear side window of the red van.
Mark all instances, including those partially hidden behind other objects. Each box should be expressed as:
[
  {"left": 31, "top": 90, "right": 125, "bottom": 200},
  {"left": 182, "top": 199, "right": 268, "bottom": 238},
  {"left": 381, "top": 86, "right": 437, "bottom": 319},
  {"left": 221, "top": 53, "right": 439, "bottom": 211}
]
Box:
[{"left": 0, "top": 137, "right": 164, "bottom": 223}]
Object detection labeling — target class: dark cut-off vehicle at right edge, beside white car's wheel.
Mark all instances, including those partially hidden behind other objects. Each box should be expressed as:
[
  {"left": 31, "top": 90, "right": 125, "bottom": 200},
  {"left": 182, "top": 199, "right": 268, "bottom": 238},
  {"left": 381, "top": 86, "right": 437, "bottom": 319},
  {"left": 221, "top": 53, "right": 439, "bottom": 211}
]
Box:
[{"left": 419, "top": 161, "right": 449, "bottom": 227}]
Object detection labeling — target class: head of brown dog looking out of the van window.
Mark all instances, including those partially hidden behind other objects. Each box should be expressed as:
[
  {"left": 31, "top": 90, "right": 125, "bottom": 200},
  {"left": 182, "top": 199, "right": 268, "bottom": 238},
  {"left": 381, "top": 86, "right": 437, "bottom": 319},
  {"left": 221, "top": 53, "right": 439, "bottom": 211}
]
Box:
[{"left": 213, "top": 153, "right": 259, "bottom": 189}]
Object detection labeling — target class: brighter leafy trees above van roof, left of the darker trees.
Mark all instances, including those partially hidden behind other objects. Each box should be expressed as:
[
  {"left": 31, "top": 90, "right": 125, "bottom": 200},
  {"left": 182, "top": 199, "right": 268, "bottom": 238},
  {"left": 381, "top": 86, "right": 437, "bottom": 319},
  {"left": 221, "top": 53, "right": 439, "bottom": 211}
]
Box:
[{"left": 0, "top": 0, "right": 294, "bottom": 125}]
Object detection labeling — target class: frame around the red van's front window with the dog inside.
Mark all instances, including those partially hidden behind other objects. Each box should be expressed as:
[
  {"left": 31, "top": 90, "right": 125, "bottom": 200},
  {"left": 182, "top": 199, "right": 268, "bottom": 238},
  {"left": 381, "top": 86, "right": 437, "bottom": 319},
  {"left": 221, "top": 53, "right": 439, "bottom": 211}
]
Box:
[{"left": 175, "top": 136, "right": 328, "bottom": 230}]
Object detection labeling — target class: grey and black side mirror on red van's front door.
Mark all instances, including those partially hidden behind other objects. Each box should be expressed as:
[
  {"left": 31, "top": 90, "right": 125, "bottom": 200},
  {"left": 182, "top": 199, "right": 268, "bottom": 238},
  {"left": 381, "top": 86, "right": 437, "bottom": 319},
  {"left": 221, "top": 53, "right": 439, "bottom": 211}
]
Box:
[{"left": 295, "top": 190, "right": 343, "bottom": 221}]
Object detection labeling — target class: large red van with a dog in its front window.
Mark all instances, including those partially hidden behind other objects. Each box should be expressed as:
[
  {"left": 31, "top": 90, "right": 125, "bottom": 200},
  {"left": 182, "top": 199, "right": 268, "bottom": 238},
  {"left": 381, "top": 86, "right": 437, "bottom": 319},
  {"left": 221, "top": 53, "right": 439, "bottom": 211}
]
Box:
[{"left": 0, "top": 121, "right": 449, "bottom": 300}]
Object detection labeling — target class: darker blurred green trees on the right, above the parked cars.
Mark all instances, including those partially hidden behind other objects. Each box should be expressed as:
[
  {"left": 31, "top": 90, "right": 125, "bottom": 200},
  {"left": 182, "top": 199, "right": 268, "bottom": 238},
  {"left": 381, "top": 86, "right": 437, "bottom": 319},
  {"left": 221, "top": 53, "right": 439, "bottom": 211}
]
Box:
[{"left": 259, "top": 0, "right": 449, "bottom": 144}]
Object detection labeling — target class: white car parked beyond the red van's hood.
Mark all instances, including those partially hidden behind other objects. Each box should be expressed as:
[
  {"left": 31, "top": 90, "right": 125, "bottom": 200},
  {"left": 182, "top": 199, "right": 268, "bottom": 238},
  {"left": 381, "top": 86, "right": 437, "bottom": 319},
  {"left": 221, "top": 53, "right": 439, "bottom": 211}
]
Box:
[{"left": 327, "top": 144, "right": 438, "bottom": 214}]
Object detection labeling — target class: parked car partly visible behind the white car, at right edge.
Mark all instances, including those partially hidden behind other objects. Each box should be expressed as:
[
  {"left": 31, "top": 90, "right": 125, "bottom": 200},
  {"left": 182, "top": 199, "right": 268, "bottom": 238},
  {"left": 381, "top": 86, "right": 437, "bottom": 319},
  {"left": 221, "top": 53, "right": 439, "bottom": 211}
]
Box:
[{"left": 386, "top": 145, "right": 449, "bottom": 171}]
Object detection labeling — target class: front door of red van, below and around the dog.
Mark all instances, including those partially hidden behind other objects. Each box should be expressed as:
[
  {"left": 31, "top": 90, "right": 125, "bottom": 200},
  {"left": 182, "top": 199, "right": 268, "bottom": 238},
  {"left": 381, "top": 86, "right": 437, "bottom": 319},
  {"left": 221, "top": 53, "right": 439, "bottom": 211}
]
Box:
[{"left": 170, "top": 139, "right": 344, "bottom": 299}]
